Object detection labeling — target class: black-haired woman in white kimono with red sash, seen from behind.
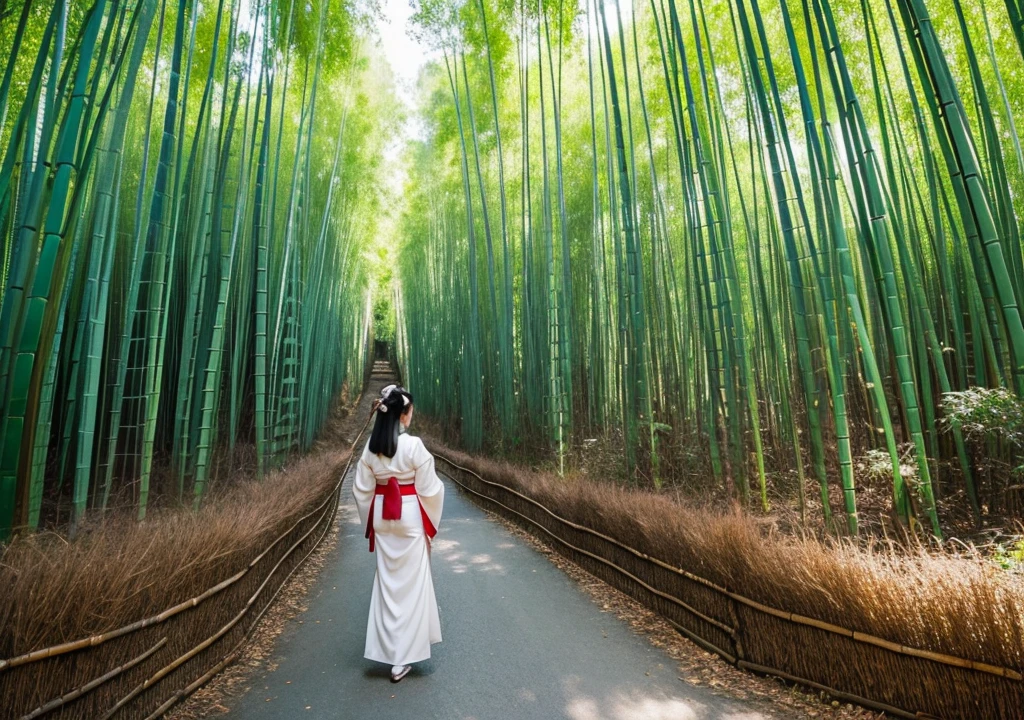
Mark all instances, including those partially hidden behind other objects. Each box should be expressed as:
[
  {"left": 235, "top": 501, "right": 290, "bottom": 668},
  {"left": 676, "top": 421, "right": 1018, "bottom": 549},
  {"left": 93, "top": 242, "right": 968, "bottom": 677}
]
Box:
[{"left": 352, "top": 385, "right": 444, "bottom": 682}]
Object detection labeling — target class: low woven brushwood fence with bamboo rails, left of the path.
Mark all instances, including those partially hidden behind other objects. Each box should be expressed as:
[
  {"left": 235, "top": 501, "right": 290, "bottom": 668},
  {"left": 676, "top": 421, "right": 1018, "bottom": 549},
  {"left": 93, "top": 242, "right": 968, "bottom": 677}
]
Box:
[{"left": 0, "top": 426, "right": 365, "bottom": 720}]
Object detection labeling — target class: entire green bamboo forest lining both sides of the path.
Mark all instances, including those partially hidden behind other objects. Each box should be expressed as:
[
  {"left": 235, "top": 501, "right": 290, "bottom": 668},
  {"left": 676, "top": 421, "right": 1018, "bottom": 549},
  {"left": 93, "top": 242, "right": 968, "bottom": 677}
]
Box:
[{"left": 0, "top": 0, "right": 1024, "bottom": 537}]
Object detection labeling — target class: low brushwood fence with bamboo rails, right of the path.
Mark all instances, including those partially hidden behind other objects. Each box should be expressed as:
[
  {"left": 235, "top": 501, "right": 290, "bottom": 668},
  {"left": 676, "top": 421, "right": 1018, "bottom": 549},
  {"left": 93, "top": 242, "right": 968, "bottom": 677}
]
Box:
[{"left": 432, "top": 450, "right": 1024, "bottom": 719}]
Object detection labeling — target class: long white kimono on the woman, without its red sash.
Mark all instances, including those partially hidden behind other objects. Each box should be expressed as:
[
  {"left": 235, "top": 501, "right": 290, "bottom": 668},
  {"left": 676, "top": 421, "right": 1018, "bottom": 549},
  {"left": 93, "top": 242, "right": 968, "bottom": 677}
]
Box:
[{"left": 352, "top": 433, "right": 444, "bottom": 665}]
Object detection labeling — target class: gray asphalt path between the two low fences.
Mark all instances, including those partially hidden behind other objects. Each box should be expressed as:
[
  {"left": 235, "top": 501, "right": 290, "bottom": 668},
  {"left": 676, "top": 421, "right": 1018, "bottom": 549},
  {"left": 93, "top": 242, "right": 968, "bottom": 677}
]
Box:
[{"left": 227, "top": 471, "right": 767, "bottom": 720}]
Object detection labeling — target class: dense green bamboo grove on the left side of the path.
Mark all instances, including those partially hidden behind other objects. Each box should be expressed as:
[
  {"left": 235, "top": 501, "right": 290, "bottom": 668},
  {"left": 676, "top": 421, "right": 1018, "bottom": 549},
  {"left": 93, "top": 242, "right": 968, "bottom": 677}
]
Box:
[{"left": 0, "top": 0, "right": 389, "bottom": 528}]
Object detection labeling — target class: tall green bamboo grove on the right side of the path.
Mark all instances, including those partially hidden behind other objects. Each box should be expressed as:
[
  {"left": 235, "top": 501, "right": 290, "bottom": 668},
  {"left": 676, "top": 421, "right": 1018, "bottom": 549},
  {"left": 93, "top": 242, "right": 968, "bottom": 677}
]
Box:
[{"left": 397, "top": 0, "right": 1024, "bottom": 535}]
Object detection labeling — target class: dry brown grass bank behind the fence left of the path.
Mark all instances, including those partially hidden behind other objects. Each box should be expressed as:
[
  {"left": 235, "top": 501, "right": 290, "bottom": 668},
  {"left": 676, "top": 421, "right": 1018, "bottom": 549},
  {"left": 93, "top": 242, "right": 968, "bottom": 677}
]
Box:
[{"left": 0, "top": 451, "right": 347, "bottom": 658}]
